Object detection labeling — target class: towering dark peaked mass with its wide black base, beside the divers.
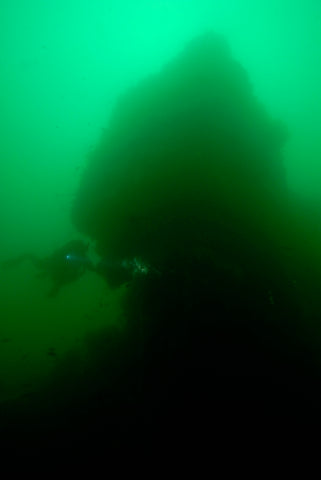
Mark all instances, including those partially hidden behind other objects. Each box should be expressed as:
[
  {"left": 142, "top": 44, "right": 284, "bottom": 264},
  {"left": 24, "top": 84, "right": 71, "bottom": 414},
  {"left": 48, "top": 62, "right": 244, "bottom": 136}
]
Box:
[{"left": 4, "top": 33, "right": 321, "bottom": 454}]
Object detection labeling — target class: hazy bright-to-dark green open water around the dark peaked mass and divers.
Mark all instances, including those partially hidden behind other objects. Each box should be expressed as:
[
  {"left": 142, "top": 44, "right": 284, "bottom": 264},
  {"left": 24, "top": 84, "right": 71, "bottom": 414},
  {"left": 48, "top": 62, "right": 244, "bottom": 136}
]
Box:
[{"left": 0, "top": 0, "right": 321, "bottom": 448}]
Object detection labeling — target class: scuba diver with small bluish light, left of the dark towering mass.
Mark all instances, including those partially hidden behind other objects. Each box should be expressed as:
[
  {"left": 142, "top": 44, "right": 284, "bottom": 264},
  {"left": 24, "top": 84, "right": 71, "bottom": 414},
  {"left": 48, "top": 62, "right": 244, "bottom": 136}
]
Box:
[{"left": 1, "top": 240, "right": 96, "bottom": 297}]
